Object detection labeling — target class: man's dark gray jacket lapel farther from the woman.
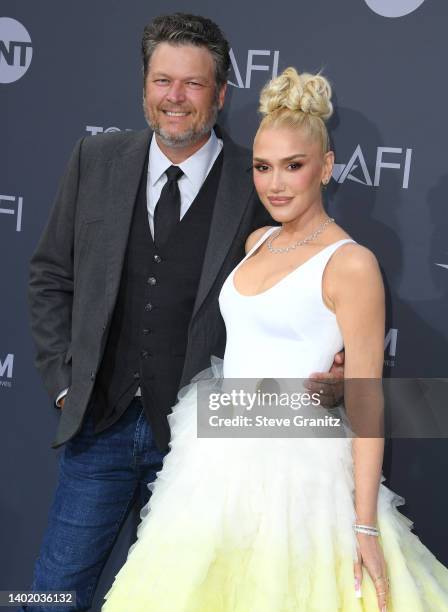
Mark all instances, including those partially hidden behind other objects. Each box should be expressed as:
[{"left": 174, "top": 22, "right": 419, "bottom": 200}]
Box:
[{"left": 105, "top": 129, "right": 152, "bottom": 320}]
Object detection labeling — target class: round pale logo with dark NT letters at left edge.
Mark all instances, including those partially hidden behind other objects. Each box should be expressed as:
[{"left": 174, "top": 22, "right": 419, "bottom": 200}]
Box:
[{"left": 0, "top": 17, "right": 33, "bottom": 83}]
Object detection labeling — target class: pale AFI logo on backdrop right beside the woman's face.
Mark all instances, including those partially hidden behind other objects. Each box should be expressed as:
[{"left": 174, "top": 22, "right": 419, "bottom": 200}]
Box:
[{"left": 333, "top": 145, "right": 412, "bottom": 189}]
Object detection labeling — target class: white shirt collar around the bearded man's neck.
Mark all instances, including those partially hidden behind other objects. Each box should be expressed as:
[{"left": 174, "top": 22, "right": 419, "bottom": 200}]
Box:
[{"left": 148, "top": 130, "right": 219, "bottom": 186}]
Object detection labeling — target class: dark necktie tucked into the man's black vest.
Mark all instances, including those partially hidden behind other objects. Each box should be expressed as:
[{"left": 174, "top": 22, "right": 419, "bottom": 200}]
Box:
[{"left": 154, "top": 166, "right": 183, "bottom": 246}]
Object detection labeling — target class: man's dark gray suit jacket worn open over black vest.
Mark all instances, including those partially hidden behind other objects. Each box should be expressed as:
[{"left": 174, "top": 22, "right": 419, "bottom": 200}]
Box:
[{"left": 30, "top": 130, "right": 272, "bottom": 447}]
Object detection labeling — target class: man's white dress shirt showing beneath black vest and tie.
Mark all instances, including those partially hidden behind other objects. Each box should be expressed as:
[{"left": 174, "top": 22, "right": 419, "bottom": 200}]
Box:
[{"left": 56, "top": 130, "right": 223, "bottom": 406}]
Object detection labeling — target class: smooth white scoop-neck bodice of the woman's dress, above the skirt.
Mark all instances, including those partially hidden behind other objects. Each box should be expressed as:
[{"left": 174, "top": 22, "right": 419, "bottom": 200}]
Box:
[{"left": 219, "top": 227, "right": 353, "bottom": 378}]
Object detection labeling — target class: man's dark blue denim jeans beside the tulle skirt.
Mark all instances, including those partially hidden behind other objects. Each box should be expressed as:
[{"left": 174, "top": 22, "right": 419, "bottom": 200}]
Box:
[{"left": 21, "top": 398, "right": 166, "bottom": 612}]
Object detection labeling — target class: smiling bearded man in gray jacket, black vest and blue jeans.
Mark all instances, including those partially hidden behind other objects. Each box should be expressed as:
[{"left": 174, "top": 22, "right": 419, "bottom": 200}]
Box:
[{"left": 27, "top": 14, "right": 344, "bottom": 612}]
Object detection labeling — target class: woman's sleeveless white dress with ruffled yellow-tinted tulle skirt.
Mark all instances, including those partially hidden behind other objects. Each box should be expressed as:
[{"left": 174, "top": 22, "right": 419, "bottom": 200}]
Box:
[{"left": 103, "top": 228, "right": 448, "bottom": 612}]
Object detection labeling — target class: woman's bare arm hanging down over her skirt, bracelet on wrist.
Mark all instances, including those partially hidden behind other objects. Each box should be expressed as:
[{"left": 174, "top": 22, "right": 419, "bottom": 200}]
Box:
[{"left": 323, "top": 244, "right": 387, "bottom": 610}]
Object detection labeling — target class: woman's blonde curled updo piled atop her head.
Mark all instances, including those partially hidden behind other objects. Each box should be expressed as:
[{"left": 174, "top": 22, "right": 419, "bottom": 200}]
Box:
[{"left": 258, "top": 67, "right": 333, "bottom": 154}]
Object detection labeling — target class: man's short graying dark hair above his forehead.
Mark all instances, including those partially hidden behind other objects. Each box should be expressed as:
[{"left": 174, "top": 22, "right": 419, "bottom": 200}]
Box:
[{"left": 142, "top": 13, "right": 230, "bottom": 91}]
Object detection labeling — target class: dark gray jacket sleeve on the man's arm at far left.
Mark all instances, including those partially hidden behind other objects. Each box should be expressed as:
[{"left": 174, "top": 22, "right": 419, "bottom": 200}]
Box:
[{"left": 29, "top": 140, "right": 83, "bottom": 401}]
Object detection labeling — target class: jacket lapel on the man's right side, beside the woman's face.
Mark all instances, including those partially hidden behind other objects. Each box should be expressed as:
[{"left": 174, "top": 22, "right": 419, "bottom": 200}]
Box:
[{"left": 192, "top": 134, "right": 254, "bottom": 317}]
